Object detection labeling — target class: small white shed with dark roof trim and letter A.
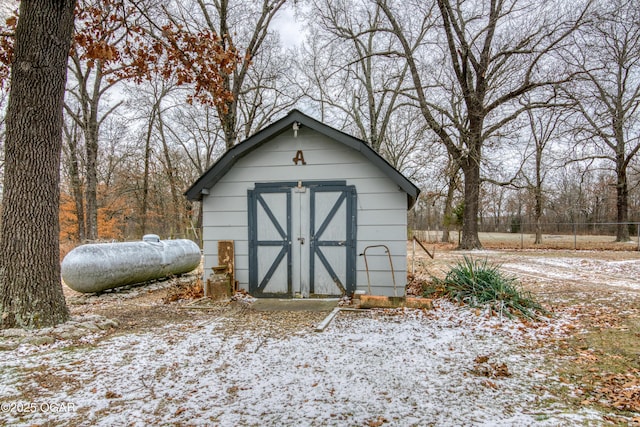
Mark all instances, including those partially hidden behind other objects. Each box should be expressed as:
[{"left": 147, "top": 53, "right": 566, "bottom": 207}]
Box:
[{"left": 185, "top": 110, "right": 420, "bottom": 298}]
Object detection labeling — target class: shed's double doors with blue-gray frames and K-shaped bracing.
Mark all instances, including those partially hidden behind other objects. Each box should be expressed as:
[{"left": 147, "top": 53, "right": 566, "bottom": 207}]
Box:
[{"left": 248, "top": 182, "right": 357, "bottom": 297}]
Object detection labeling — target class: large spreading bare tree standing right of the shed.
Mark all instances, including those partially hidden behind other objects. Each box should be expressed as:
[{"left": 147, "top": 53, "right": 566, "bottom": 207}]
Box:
[{"left": 376, "top": 0, "right": 583, "bottom": 249}]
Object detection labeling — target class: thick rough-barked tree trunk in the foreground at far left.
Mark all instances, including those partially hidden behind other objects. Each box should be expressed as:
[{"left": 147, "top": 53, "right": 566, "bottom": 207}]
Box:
[{"left": 0, "top": 0, "right": 75, "bottom": 328}]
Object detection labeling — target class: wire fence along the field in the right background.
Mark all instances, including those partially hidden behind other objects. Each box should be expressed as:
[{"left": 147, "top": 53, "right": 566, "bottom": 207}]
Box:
[{"left": 409, "top": 222, "right": 640, "bottom": 251}]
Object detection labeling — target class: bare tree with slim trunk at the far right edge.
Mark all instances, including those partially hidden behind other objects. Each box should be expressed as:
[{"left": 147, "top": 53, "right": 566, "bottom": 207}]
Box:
[{"left": 566, "top": 0, "right": 640, "bottom": 242}]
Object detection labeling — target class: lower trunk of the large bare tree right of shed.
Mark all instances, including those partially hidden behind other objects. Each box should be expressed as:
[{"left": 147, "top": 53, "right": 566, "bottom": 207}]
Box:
[{"left": 460, "top": 156, "right": 482, "bottom": 249}]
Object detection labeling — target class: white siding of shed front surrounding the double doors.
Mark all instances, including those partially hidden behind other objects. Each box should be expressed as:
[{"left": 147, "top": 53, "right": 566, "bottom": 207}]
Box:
[{"left": 203, "top": 127, "right": 407, "bottom": 295}]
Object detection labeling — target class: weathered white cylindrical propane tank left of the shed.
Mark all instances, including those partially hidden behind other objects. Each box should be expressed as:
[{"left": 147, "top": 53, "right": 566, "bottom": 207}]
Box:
[{"left": 61, "top": 234, "right": 200, "bottom": 293}]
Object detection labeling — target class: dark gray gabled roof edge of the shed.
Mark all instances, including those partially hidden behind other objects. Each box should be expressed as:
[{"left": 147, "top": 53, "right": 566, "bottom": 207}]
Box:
[{"left": 184, "top": 110, "right": 420, "bottom": 209}]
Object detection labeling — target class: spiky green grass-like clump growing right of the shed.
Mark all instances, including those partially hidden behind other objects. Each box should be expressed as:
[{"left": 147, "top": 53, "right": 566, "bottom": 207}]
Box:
[{"left": 431, "top": 256, "right": 549, "bottom": 319}]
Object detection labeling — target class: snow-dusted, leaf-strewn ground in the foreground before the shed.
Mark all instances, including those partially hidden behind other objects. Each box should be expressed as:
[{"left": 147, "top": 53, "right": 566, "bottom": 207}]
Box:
[{"left": 0, "top": 301, "right": 599, "bottom": 426}]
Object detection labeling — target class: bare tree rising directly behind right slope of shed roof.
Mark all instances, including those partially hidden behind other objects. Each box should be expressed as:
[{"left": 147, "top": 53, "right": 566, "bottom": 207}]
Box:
[{"left": 300, "top": 0, "right": 410, "bottom": 151}]
